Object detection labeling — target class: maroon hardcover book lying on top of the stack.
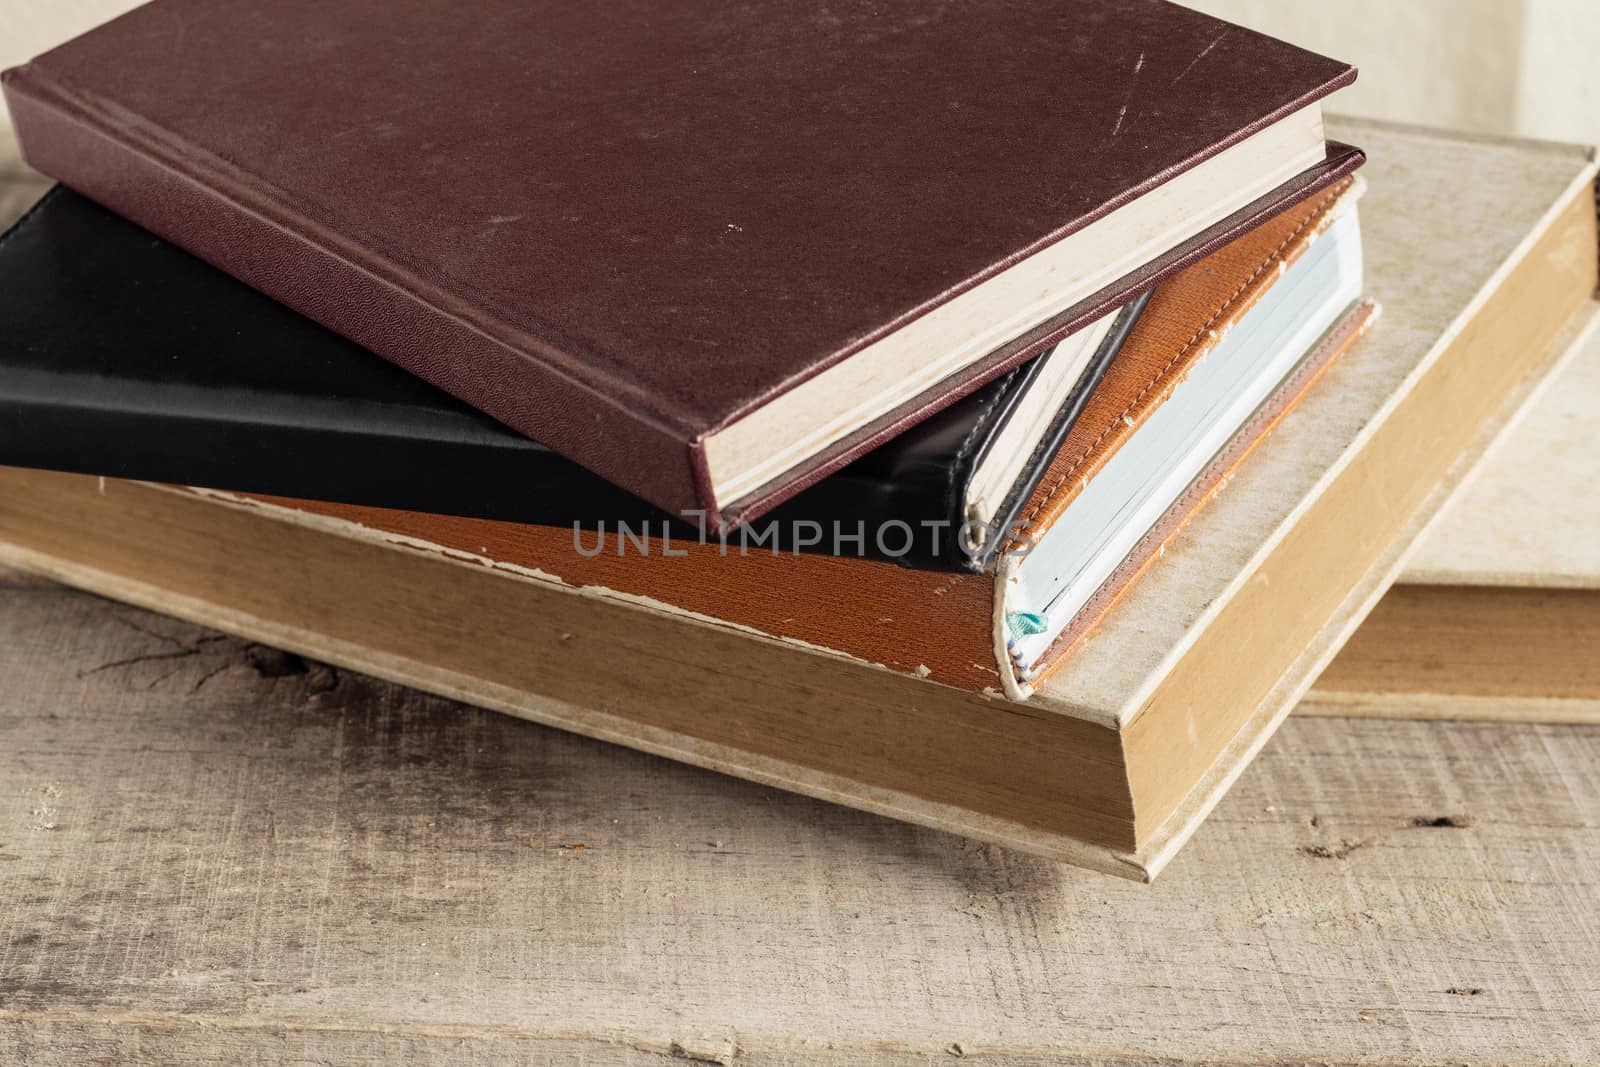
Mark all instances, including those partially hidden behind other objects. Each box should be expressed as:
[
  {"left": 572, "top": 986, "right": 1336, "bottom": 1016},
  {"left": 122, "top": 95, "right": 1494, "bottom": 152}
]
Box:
[{"left": 5, "top": 0, "right": 1362, "bottom": 530}]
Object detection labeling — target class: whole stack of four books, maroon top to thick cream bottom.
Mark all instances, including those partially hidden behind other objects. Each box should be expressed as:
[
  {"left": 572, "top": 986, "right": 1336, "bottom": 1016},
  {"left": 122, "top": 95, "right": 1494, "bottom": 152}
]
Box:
[{"left": 0, "top": 0, "right": 1595, "bottom": 877}]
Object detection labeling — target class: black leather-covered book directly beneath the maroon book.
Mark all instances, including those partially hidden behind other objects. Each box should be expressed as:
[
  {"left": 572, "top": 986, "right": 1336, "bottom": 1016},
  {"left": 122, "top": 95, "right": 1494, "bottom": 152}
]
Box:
[{"left": 0, "top": 187, "right": 1144, "bottom": 569}]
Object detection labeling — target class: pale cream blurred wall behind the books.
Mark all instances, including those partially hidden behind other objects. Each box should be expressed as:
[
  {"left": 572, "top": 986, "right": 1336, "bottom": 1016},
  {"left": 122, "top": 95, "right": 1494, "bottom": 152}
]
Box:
[{"left": 0, "top": 0, "right": 1600, "bottom": 144}]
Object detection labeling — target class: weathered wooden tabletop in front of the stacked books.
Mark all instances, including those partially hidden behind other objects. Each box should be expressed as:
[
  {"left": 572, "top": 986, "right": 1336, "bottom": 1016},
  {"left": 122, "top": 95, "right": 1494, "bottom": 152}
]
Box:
[{"left": 0, "top": 573, "right": 1600, "bottom": 1067}]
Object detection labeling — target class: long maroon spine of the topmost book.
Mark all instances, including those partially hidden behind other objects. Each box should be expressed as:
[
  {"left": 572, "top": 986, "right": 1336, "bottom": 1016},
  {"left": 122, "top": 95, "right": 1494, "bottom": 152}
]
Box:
[{"left": 5, "top": 66, "right": 717, "bottom": 528}]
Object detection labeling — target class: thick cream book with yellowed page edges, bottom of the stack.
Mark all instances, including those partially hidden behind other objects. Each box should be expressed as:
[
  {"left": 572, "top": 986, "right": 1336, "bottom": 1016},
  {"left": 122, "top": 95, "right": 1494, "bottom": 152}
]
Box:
[{"left": 0, "top": 125, "right": 1600, "bottom": 878}]
